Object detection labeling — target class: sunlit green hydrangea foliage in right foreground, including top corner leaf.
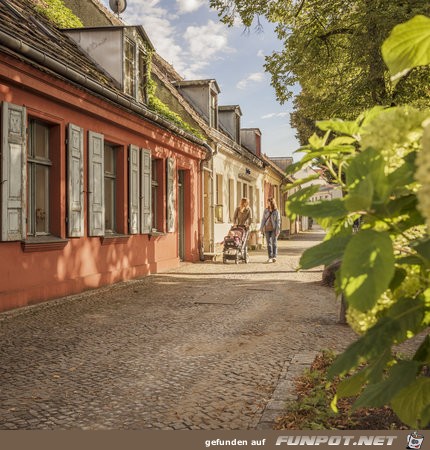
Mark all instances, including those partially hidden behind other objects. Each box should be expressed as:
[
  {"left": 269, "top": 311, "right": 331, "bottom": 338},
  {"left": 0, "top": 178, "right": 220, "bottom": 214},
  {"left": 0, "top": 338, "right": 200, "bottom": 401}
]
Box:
[{"left": 288, "top": 17, "right": 430, "bottom": 428}]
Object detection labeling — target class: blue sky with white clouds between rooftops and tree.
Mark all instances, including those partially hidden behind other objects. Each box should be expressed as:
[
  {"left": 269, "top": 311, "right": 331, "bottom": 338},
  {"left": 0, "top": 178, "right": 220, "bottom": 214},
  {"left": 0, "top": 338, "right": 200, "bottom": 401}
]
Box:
[{"left": 101, "top": 0, "right": 299, "bottom": 160}]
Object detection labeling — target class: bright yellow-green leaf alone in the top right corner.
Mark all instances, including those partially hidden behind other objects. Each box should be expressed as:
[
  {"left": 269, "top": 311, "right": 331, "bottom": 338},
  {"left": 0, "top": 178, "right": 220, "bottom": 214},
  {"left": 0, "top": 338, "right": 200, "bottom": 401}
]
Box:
[{"left": 382, "top": 15, "right": 430, "bottom": 84}]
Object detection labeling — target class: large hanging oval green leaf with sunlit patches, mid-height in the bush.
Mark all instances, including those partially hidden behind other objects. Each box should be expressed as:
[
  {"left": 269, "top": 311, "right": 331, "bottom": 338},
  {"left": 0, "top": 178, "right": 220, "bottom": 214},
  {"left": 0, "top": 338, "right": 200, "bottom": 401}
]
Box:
[{"left": 340, "top": 230, "right": 394, "bottom": 312}]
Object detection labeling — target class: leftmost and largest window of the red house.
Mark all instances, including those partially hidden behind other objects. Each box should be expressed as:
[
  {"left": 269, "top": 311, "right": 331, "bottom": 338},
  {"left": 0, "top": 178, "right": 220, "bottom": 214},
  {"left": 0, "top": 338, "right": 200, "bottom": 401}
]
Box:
[{"left": 27, "top": 119, "right": 52, "bottom": 236}]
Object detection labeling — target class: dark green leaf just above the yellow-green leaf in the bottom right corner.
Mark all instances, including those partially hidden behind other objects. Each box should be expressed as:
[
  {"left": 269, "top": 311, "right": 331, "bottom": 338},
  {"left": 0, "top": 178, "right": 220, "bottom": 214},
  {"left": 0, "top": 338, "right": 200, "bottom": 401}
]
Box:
[{"left": 353, "top": 361, "right": 421, "bottom": 409}]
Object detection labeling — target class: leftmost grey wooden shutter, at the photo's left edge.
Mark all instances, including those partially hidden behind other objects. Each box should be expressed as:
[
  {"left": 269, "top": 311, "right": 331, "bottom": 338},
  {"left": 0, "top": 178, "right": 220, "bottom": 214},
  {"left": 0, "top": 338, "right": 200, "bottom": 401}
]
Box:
[{"left": 0, "top": 102, "right": 27, "bottom": 241}]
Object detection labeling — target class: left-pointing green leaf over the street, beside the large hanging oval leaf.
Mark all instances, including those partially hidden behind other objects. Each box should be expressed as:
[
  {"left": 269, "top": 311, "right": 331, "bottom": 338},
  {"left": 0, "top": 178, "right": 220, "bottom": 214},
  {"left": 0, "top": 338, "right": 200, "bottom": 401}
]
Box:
[{"left": 300, "top": 235, "right": 352, "bottom": 269}]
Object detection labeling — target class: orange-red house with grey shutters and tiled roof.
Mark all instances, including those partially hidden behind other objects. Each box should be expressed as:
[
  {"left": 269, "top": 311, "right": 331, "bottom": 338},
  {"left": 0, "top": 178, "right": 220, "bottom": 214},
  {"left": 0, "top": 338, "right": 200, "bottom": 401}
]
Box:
[{"left": 0, "top": 0, "right": 208, "bottom": 311}]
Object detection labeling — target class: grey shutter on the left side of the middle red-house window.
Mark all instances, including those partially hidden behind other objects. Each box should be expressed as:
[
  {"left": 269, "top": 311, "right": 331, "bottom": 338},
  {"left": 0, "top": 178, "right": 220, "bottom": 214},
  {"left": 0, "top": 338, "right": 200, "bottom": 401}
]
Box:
[{"left": 88, "top": 131, "right": 105, "bottom": 236}]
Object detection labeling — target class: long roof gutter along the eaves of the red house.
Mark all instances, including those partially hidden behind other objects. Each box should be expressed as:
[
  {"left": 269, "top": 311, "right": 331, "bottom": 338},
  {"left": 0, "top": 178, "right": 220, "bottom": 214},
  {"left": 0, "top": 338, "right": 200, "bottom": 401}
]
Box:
[{"left": 0, "top": 30, "right": 213, "bottom": 159}]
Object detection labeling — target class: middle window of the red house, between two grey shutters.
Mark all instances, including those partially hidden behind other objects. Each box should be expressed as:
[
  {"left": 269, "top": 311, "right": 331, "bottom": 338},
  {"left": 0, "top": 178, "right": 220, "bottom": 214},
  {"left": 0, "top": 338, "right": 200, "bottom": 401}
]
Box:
[{"left": 104, "top": 143, "right": 117, "bottom": 233}]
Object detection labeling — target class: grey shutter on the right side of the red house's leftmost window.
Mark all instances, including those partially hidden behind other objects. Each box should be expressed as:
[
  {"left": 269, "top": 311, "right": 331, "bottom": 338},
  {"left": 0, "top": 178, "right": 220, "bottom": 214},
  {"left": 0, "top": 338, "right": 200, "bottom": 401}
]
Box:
[{"left": 67, "top": 124, "right": 84, "bottom": 237}]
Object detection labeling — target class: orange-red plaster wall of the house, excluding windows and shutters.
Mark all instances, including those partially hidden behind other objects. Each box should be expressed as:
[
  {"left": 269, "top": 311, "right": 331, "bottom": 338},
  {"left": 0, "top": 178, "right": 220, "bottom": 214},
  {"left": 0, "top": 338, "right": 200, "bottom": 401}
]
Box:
[{"left": 0, "top": 54, "right": 205, "bottom": 311}]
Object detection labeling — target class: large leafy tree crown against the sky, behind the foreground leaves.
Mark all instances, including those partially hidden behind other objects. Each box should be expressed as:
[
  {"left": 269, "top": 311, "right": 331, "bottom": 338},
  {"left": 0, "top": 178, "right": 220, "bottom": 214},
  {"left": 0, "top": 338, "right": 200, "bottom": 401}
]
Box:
[{"left": 210, "top": 0, "right": 430, "bottom": 145}]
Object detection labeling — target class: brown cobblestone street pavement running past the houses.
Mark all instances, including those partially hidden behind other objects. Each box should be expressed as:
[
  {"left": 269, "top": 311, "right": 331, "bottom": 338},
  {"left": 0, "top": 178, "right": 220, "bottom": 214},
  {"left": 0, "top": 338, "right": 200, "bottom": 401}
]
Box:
[{"left": 0, "top": 230, "right": 354, "bottom": 430}]
